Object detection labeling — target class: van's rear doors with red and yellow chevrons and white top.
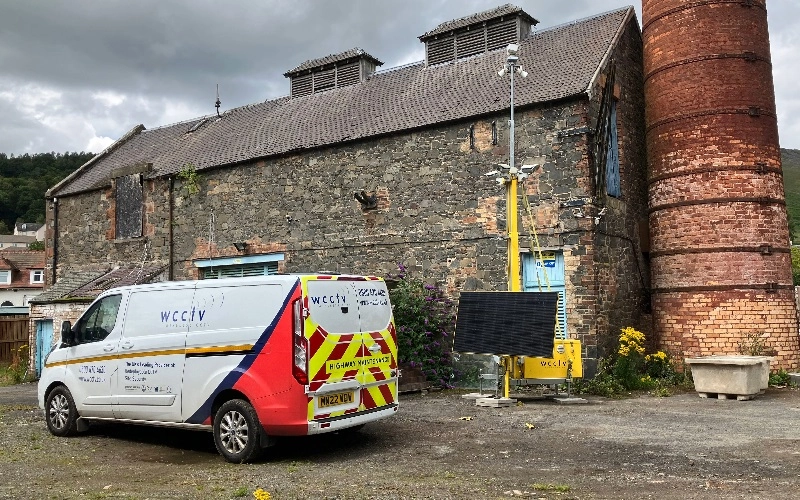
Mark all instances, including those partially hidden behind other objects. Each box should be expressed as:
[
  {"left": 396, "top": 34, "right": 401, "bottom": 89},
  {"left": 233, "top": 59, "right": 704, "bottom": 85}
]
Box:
[{"left": 303, "top": 276, "right": 397, "bottom": 420}]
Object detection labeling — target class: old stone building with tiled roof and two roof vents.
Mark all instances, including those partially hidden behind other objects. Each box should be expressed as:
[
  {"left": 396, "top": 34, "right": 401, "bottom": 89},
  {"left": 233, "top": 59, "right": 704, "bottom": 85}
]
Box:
[{"left": 40, "top": 5, "right": 650, "bottom": 373}]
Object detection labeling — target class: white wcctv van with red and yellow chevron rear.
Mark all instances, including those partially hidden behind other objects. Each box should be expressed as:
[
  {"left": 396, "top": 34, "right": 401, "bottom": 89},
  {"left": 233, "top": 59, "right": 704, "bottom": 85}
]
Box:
[{"left": 39, "top": 275, "right": 398, "bottom": 462}]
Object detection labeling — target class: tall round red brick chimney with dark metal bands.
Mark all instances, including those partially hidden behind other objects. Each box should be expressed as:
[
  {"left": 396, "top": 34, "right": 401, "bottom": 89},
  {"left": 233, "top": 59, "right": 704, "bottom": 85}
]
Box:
[{"left": 642, "top": 0, "right": 800, "bottom": 369}]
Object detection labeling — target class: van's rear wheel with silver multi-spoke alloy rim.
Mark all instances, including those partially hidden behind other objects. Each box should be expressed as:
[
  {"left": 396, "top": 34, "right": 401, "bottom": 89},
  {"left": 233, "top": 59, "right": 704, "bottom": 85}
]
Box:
[{"left": 214, "top": 399, "right": 262, "bottom": 463}]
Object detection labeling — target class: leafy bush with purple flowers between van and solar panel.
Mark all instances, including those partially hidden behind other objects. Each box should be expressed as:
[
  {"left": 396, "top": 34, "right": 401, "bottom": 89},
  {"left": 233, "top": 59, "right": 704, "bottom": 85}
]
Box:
[{"left": 389, "top": 264, "right": 456, "bottom": 387}]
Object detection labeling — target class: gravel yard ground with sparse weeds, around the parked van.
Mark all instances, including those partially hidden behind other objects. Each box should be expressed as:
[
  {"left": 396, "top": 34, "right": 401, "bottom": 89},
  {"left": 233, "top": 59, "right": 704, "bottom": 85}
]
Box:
[{"left": 0, "top": 384, "right": 800, "bottom": 500}]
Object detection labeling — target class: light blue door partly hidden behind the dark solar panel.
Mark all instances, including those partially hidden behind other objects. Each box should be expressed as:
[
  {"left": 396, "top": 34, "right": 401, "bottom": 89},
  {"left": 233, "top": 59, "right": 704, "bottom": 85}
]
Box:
[{"left": 522, "top": 250, "right": 567, "bottom": 339}]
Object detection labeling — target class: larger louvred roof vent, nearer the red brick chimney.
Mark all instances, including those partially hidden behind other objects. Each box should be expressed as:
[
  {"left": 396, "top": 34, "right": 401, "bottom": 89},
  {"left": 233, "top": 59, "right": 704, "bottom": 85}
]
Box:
[{"left": 419, "top": 3, "right": 539, "bottom": 65}]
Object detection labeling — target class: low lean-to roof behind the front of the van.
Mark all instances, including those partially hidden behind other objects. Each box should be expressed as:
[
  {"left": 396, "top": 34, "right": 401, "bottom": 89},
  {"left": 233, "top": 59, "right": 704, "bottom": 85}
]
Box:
[{"left": 29, "top": 266, "right": 164, "bottom": 304}]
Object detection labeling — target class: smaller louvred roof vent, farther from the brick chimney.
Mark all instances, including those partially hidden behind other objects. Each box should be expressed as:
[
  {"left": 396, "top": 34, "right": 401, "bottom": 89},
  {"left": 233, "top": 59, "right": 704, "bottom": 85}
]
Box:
[{"left": 283, "top": 48, "right": 383, "bottom": 97}]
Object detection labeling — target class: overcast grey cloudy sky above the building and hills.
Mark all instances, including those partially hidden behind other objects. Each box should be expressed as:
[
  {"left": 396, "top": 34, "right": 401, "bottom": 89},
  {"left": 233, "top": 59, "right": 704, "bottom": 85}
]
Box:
[{"left": 0, "top": 0, "right": 800, "bottom": 155}]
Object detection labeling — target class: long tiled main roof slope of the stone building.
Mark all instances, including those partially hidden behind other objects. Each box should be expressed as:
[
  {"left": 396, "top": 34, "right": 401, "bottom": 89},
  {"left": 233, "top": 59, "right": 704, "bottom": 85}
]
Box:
[{"left": 47, "top": 7, "right": 635, "bottom": 197}]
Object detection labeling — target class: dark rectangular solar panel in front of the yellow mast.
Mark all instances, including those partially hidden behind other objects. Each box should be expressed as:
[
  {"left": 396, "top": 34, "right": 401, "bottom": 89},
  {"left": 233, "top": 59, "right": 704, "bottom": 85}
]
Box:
[{"left": 453, "top": 292, "right": 558, "bottom": 358}]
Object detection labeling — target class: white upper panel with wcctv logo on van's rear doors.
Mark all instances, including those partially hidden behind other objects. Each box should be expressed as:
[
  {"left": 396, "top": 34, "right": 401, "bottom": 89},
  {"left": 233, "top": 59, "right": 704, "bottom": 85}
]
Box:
[{"left": 308, "top": 280, "right": 392, "bottom": 333}]
